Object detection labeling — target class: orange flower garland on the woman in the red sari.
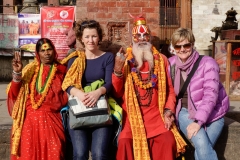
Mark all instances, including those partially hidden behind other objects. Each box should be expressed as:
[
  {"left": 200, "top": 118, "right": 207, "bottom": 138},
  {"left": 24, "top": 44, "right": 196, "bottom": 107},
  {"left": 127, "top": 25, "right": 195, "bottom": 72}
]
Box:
[{"left": 30, "top": 63, "right": 57, "bottom": 109}]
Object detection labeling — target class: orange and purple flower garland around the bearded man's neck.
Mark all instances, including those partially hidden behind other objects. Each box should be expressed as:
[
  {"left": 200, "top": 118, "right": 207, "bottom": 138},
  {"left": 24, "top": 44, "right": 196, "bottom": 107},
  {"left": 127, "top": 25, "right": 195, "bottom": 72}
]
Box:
[{"left": 127, "top": 48, "right": 159, "bottom": 89}]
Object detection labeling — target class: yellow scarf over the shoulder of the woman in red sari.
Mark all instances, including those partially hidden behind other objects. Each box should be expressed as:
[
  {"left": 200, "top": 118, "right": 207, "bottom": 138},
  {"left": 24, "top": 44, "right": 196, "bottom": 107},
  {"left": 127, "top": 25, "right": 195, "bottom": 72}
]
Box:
[{"left": 7, "top": 59, "right": 38, "bottom": 156}]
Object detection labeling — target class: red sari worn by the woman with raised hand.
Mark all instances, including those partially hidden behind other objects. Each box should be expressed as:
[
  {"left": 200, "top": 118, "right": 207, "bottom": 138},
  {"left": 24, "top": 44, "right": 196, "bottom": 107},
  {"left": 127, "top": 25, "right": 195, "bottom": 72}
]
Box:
[{"left": 8, "top": 65, "right": 67, "bottom": 160}]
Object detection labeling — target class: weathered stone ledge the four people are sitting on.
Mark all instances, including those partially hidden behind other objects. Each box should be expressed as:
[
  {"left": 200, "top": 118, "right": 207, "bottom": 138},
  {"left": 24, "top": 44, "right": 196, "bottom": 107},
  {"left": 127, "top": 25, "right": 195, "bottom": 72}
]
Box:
[{"left": 0, "top": 117, "right": 240, "bottom": 160}]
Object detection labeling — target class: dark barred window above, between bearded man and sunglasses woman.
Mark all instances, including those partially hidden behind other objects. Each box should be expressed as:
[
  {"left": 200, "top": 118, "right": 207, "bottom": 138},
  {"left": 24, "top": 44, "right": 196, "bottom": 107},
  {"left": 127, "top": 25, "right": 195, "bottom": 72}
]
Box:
[{"left": 159, "top": 0, "right": 180, "bottom": 27}]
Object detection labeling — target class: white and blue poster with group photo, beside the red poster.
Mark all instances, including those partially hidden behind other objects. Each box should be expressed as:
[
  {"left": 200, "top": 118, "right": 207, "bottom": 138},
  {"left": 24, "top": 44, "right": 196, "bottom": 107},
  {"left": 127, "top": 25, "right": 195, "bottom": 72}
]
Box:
[{"left": 18, "top": 13, "right": 41, "bottom": 52}]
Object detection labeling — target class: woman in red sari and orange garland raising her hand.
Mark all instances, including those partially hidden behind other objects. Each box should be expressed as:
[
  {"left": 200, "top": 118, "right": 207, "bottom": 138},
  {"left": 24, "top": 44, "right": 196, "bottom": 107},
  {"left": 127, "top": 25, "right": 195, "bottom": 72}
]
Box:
[{"left": 7, "top": 38, "right": 68, "bottom": 160}]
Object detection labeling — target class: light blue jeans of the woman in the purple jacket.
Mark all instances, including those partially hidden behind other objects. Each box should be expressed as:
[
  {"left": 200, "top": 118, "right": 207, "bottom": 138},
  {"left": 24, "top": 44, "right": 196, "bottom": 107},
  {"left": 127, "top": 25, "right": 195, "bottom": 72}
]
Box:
[{"left": 179, "top": 107, "right": 224, "bottom": 160}]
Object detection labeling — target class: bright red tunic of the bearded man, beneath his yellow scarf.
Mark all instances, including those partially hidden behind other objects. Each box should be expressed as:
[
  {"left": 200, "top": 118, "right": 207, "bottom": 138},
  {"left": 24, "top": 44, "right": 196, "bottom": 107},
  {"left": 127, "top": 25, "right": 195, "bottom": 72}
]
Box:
[{"left": 112, "top": 56, "right": 176, "bottom": 140}]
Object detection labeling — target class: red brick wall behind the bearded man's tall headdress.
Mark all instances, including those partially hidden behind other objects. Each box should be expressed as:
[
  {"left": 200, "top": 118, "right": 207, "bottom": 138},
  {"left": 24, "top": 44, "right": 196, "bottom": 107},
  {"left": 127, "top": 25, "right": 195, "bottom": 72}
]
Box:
[{"left": 76, "top": 0, "right": 159, "bottom": 51}]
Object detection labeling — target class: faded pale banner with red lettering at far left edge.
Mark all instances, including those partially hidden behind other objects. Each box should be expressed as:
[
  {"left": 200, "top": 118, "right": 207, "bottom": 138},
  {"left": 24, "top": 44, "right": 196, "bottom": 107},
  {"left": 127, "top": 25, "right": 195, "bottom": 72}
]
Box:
[{"left": 0, "top": 14, "right": 19, "bottom": 55}]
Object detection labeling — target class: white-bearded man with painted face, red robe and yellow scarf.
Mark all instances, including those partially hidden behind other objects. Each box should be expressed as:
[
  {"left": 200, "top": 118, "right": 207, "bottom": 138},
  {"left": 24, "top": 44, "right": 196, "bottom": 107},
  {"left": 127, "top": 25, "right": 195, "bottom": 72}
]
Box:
[{"left": 112, "top": 17, "right": 186, "bottom": 160}]
